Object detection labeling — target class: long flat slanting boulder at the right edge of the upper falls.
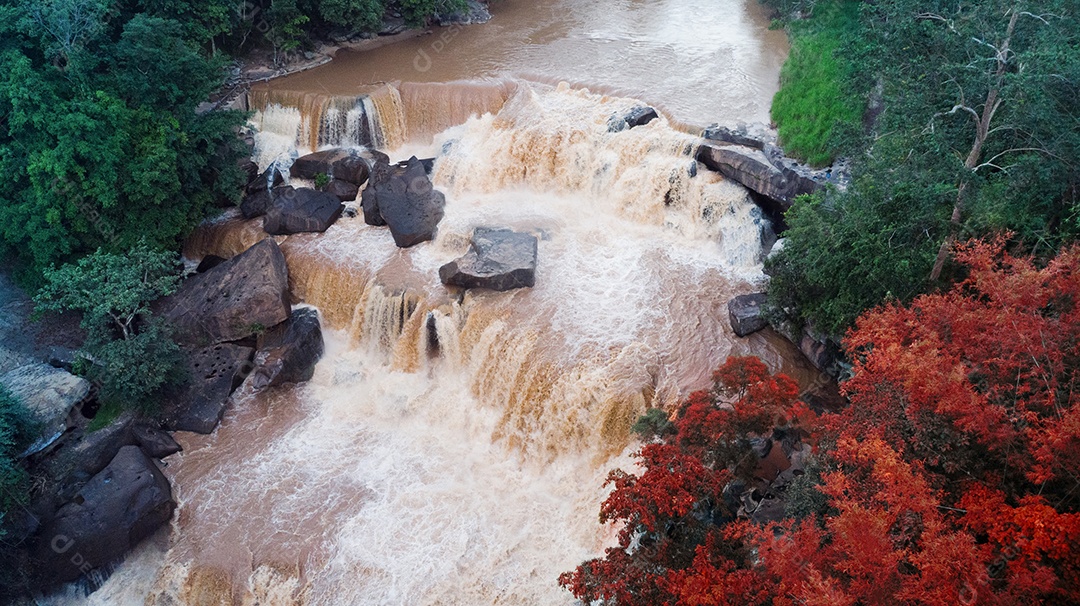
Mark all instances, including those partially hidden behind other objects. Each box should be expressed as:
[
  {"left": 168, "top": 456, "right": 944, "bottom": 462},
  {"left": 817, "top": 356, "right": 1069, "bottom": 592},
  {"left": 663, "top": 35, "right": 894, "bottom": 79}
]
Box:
[{"left": 698, "top": 143, "right": 819, "bottom": 211}]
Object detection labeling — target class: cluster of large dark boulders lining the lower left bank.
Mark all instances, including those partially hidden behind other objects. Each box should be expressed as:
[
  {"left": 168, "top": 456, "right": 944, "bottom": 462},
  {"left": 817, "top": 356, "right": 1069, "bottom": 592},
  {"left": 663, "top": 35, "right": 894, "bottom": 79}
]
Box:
[{"left": 0, "top": 238, "right": 323, "bottom": 587}]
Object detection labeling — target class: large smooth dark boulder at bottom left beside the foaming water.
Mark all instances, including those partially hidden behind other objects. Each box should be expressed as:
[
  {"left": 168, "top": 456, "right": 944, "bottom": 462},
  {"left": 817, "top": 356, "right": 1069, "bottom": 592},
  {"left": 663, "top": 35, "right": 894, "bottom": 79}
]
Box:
[{"left": 35, "top": 446, "right": 176, "bottom": 584}]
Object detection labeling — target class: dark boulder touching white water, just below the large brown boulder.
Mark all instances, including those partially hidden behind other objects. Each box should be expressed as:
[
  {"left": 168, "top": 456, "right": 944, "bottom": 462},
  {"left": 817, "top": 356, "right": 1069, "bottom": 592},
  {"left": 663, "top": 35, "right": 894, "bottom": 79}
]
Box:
[{"left": 252, "top": 309, "right": 323, "bottom": 390}]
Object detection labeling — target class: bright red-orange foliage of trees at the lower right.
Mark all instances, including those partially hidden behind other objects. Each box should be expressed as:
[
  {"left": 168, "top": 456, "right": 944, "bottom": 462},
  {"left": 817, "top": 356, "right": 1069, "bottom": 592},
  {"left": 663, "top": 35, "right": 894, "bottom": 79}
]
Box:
[{"left": 561, "top": 239, "right": 1080, "bottom": 606}]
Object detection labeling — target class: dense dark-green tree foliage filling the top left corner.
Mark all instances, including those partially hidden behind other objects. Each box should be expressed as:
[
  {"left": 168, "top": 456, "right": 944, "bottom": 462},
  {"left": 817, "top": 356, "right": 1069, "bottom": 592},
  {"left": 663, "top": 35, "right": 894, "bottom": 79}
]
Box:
[{"left": 0, "top": 0, "right": 243, "bottom": 277}]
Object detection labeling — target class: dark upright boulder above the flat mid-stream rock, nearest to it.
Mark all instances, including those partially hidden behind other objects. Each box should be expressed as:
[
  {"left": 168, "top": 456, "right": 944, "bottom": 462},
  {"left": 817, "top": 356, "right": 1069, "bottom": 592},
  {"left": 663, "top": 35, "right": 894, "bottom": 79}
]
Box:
[{"left": 362, "top": 157, "right": 446, "bottom": 248}]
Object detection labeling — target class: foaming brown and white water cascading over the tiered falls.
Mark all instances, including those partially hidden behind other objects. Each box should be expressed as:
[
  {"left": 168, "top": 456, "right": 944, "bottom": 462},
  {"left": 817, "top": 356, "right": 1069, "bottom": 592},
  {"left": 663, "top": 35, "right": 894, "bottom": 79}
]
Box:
[{"left": 46, "top": 75, "right": 816, "bottom": 605}]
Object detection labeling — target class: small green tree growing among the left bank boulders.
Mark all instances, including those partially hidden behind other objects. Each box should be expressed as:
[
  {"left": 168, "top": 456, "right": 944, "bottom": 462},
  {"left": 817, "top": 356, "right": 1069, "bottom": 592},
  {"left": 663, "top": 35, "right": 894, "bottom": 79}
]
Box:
[{"left": 35, "top": 243, "right": 181, "bottom": 408}]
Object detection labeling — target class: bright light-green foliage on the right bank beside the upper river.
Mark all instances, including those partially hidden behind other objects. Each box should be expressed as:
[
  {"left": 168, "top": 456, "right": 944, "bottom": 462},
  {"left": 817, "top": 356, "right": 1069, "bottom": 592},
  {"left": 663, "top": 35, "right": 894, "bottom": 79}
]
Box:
[{"left": 771, "top": 1, "right": 865, "bottom": 166}]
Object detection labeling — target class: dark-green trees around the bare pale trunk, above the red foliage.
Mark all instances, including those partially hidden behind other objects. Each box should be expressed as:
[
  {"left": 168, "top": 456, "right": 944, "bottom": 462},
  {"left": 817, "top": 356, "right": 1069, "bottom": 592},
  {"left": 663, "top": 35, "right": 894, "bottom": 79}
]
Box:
[{"left": 768, "top": 0, "right": 1080, "bottom": 335}]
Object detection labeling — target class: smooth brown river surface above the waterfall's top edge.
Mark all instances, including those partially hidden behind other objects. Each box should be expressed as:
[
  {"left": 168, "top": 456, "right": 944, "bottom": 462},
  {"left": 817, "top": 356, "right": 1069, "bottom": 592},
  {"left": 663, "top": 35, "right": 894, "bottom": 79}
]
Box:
[{"left": 264, "top": 0, "right": 788, "bottom": 127}]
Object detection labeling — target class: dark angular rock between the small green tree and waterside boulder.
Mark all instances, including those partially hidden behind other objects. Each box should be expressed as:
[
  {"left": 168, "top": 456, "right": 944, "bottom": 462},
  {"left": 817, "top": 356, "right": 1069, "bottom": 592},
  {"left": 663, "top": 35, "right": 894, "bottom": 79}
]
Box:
[{"left": 162, "top": 344, "right": 255, "bottom": 433}]
